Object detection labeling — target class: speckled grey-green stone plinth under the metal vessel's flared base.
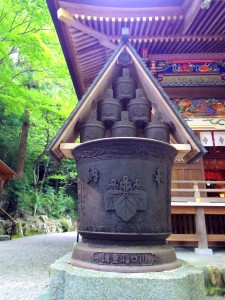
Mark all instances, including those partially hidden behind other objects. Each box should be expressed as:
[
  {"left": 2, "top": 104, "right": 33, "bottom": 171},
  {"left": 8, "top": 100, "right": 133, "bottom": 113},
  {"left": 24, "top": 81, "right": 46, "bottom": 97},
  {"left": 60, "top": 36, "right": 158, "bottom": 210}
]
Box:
[{"left": 38, "top": 255, "right": 206, "bottom": 300}]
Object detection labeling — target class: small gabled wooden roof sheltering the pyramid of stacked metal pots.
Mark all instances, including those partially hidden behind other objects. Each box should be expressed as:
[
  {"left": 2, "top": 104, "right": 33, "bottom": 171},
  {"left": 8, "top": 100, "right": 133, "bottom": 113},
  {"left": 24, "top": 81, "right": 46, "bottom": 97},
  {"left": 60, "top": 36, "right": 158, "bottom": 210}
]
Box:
[{"left": 47, "top": 36, "right": 206, "bottom": 163}]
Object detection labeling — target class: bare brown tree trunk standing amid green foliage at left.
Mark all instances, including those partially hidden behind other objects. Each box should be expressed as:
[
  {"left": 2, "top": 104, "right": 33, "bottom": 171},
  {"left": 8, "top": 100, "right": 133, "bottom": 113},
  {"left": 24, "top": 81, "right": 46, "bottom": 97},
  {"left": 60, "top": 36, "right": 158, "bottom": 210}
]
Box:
[{"left": 16, "top": 109, "right": 30, "bottom": 178}]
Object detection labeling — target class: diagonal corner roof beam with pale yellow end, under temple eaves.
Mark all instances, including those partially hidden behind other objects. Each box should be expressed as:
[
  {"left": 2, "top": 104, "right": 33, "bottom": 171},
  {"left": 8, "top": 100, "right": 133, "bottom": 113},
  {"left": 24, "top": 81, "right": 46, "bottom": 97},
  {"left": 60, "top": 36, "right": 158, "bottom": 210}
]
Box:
[{"left": 57, "top": 8, "right": 116, "bottom": 50}]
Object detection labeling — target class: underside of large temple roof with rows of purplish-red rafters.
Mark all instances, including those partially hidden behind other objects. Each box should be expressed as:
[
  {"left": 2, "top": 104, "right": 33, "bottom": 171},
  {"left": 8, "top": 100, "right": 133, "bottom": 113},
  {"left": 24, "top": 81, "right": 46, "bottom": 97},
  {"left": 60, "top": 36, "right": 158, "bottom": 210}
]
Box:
[{"left": 47, "top": 0, "right": 225, "bottom": 99}]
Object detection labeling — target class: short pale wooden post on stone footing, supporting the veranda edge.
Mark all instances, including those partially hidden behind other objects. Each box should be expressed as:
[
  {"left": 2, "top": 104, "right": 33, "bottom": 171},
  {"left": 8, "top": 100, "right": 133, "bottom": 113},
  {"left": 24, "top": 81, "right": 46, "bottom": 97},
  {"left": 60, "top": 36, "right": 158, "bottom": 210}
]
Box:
[{"left": 195, "top": 206, "right": 213, "bottom": 254}]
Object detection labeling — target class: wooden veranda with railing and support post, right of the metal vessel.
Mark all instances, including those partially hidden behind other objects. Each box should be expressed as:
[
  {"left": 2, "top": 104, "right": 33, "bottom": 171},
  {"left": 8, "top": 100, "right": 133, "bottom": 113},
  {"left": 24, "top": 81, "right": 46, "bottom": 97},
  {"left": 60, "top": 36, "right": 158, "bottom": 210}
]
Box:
[{"left": 168, "top": 180, "right": 225, "bottom": 253}]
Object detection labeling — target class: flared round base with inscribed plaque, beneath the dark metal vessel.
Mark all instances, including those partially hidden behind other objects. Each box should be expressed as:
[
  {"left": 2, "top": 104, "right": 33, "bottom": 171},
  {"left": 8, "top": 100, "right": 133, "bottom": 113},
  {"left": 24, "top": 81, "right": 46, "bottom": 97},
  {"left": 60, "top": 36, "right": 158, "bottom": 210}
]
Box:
[{"left": 69, "top": 240, "right": 180, "bottom": 273}]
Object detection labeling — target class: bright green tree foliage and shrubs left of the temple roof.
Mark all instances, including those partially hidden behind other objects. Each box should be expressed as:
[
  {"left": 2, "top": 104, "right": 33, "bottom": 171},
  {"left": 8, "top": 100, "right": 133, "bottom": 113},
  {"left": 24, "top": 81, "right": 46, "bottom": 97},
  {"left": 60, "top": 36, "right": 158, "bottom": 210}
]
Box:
[{"left": 0, "top": 0, "right": 77, "bottom": 215}]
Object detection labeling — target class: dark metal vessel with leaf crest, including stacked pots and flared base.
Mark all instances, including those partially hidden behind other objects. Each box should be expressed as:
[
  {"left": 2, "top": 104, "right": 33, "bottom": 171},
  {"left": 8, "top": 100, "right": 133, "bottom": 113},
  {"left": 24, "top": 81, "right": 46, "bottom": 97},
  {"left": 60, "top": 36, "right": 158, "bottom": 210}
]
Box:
[{"left": 70, "top": 68, "right": 179, "bottom": 272}]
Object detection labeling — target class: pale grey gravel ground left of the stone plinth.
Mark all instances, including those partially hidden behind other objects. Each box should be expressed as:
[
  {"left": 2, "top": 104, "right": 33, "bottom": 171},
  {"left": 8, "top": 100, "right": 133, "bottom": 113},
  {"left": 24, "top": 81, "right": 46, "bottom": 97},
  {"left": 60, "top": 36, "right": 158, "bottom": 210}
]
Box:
[{"left": 0, "top": 232, "right": 76, "bottom": 300}]
